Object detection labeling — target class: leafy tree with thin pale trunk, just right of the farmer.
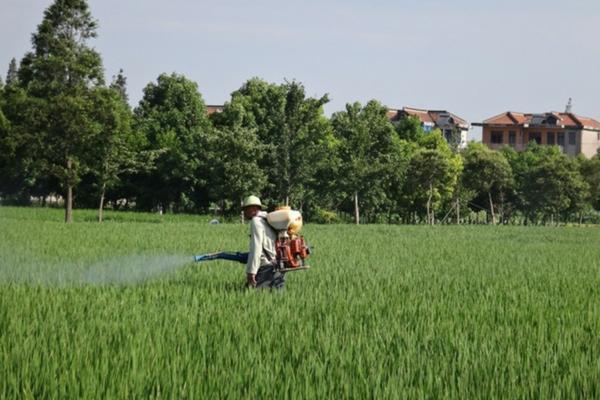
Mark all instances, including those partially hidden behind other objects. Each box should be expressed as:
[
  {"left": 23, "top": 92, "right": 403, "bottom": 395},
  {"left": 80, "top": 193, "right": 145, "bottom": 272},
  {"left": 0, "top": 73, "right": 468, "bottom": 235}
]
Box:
[{"left": 331, "top": 100, "right": 406, "bottom": 225}]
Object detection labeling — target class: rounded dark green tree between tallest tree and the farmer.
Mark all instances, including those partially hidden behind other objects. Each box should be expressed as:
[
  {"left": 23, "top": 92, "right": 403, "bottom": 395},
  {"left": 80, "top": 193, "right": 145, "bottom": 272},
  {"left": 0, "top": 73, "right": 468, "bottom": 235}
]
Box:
[{"left": 134, "top": 74, "right": 211, "bottom": 211}]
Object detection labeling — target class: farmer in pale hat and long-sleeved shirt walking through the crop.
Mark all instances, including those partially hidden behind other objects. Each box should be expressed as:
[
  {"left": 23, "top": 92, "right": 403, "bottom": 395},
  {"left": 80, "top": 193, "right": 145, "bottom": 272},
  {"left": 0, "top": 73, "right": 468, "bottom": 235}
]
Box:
[{"left": 242, "top": 196, "right": 285, "bottom": 289}]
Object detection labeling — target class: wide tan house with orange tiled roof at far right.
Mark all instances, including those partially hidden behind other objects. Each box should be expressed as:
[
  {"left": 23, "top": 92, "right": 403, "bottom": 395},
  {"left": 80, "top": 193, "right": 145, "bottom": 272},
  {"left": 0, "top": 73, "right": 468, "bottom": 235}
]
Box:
[{"left": 473, "top": 111, "right": 600, "bottom": 157}]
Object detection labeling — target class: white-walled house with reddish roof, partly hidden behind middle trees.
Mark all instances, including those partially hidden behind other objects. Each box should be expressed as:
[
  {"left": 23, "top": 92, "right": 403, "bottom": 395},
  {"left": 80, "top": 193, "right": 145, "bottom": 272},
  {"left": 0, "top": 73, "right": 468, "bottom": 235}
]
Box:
[{"left": 387, "top": 107, "right": 470, "bottom": 148}]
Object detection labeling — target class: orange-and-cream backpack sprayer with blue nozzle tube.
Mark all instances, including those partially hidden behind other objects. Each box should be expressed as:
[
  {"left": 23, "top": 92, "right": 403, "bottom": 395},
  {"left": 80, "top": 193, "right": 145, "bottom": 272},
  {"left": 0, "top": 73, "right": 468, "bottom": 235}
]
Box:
[{"left": 194, "top": 206, "right": 310, "bottom": 272}]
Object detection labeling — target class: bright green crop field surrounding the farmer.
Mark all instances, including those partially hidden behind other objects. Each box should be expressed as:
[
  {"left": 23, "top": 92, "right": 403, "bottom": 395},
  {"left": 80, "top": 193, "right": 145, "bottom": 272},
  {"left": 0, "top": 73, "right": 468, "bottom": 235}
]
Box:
[{"left": 0, "top": 207, "right": 600, "bottom": 399}]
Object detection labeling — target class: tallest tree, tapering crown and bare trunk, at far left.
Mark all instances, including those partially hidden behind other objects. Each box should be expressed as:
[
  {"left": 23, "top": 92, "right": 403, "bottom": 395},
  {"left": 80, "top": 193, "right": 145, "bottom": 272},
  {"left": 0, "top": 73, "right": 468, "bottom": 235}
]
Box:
[{"left": 19, "top": 0, "right": 104, "bottom": 222}]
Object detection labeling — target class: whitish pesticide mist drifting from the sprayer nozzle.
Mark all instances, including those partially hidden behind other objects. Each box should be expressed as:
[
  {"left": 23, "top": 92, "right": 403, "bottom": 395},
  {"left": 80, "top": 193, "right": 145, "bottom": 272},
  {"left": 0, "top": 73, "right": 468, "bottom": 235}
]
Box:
[{"left": 0, "top": 255, "right": 192, "bottom": 286}]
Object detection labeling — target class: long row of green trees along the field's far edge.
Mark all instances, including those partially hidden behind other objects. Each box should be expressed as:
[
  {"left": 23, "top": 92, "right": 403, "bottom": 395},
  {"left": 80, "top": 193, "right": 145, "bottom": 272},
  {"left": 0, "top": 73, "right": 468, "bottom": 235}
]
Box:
[{"left": 0, "top": 0, "right": 600, "bottom": 224}]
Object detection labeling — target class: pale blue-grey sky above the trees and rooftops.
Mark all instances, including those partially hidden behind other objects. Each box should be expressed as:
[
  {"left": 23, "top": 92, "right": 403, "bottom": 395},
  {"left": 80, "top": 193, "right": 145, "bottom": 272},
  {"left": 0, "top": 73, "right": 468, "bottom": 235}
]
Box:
[{"left": 0, "top": 0, "right": 600, "bottom": 140}]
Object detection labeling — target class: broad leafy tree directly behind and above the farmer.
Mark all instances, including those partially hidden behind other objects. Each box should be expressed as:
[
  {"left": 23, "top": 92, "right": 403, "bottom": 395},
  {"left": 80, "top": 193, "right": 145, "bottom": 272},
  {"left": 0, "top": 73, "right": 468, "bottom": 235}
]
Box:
[{"left": 213, "top": 78, "right": 332, "bottom": 209}]
